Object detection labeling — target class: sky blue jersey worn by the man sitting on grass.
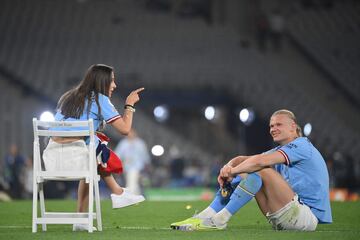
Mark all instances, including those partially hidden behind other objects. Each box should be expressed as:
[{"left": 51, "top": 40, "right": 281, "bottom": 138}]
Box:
[{"left": 265, "top": 137, "right": 332, "bottom": 223}]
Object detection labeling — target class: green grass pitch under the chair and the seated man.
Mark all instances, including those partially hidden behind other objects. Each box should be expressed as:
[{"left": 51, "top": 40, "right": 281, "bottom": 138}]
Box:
[{"left": 0, "top": 200, "right": 360, "bottom": 240}]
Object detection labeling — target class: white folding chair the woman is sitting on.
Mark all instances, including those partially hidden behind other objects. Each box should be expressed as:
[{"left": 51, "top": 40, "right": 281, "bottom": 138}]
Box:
[{"left": 32, "top": 118, "right": 102, "bottom": 232}]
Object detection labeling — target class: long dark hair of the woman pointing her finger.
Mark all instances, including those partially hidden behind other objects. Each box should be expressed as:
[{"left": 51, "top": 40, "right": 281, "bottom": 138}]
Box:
[{"left": 57, "top": 64, "right": 113, "bottom": 119}]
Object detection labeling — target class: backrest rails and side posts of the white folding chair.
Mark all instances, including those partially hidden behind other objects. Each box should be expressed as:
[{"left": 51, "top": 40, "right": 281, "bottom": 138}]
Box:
[{"left": 33, "top": 118, "right": 96, "bottom": 176}]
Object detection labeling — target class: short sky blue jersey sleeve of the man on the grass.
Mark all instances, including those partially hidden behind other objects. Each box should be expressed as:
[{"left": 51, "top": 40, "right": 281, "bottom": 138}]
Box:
[{"left": 277, "top": 140, "right": 310, "bottom": 165}]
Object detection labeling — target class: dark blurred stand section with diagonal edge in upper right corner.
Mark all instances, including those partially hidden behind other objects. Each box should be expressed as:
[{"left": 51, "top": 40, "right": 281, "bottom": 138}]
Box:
[{"left": 289, "top": 1, "right": 360, "bottom": 106}]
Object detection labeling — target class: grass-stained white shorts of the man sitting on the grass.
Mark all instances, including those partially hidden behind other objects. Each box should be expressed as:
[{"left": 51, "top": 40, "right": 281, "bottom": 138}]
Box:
[{"left": 266, "top": 195, "right": 318, "bottom": 231}]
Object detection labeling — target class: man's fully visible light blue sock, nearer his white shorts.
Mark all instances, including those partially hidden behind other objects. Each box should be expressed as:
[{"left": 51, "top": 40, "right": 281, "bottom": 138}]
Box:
[{"left": 225, "top": 173, "right": 262, "bottom": 215}]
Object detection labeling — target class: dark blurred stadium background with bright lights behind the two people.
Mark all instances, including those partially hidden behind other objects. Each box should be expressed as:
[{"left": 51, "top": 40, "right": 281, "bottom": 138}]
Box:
[{"left": 0, "top": 0, "right": 360, "bottom": 201}]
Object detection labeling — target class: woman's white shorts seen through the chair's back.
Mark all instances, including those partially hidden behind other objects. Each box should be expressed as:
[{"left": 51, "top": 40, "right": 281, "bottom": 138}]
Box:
[{"left": 43, "top": 139, "right": 89, "bottom": 171}]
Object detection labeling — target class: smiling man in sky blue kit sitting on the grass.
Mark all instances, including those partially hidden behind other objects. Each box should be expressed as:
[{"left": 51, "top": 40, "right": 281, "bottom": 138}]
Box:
[{"left": 171, "top": 110, "right": 332, "bottom": 231}]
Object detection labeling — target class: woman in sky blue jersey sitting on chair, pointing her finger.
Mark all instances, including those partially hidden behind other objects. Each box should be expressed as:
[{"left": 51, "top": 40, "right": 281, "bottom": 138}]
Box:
[{"left": 43, "top": 64, "right": 145, "bottom": 231}]
